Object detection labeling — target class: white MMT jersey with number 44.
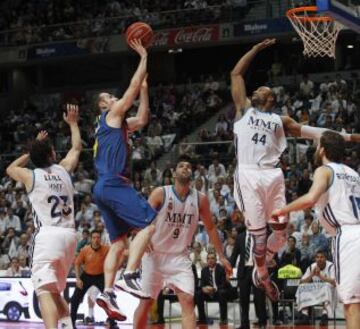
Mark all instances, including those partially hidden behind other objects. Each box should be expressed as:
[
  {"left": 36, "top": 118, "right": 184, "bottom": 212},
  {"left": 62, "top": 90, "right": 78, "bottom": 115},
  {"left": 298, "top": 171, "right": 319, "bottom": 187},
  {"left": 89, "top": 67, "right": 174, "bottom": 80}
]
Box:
[{"left": 234, "top": 107, "right": 287, "bottom": 168}]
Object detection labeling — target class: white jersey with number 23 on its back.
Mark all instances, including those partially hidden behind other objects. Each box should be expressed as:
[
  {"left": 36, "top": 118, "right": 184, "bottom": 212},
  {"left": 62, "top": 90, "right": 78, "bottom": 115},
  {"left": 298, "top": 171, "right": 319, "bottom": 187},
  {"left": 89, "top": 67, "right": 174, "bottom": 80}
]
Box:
[{"left": 29, "top": 165, "right": 75, "bottom": 228}]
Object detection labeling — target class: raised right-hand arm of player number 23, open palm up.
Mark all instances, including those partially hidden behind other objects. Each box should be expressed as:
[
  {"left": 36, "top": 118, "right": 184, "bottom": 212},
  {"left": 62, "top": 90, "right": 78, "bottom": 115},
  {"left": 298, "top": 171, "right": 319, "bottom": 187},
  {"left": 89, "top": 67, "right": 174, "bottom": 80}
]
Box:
[{"left": 59, "top": 104, "right": 82, "bottom": 172}]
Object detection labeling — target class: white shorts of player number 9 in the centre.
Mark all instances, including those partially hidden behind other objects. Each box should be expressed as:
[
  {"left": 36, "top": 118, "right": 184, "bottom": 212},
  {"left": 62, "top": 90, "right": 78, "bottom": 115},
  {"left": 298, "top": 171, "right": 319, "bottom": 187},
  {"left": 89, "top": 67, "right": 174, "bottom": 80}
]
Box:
[{"left": 142, "top": 252, "right": 195, "bottom": 299}]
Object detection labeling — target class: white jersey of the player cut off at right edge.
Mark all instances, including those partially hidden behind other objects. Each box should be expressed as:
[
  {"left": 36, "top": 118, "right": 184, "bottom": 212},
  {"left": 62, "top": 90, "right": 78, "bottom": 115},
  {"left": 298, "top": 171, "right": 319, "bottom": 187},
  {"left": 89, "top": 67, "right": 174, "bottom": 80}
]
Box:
[{"left": 316, "top": 162, "right": 360, "bottom": 235}]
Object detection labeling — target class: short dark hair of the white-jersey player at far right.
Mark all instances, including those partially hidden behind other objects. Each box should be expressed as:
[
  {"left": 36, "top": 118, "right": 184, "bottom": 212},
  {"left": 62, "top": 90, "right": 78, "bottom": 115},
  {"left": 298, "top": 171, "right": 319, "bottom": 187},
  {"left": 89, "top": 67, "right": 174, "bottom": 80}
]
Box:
[{"left": 320, "top": 130, "right": 345, "bottom": 162}]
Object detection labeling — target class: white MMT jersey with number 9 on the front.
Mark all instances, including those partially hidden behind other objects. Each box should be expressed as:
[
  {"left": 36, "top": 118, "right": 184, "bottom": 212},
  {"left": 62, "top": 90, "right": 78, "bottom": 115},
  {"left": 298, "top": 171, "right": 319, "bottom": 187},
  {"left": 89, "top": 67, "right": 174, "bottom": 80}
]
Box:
[{"left": 151, "top": 185, "right": 199, "bottom": 254}]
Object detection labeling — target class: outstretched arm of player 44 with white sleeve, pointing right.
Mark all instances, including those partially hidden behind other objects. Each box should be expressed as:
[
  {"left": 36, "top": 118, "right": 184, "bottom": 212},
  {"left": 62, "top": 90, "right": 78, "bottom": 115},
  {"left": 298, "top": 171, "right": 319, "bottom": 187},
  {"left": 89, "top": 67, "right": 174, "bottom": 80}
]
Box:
[{"left": 281, "top": 116, "right": 360, "bottom": 143}]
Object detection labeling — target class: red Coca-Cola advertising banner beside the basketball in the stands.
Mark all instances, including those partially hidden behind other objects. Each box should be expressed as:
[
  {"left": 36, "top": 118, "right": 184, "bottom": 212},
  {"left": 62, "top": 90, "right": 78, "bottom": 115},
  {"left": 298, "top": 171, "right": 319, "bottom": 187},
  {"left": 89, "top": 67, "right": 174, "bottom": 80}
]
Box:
[{"left": 153, "top": 25, "right": 220, "bottom": 47}]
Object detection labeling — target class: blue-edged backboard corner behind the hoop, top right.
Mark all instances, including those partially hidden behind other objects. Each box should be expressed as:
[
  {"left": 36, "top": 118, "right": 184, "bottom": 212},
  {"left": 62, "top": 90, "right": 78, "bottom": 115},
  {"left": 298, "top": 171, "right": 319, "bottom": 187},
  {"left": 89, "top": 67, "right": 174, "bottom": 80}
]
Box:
[{"left": 316, "top": 0, "right": 360, "bottom": 33}]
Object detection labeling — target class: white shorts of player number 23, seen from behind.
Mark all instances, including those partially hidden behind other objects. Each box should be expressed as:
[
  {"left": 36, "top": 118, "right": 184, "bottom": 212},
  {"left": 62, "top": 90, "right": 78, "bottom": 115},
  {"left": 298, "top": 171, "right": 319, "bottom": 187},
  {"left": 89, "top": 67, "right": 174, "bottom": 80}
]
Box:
[{"left": 31, "top": 226, "right": 77, "bottom": 293}]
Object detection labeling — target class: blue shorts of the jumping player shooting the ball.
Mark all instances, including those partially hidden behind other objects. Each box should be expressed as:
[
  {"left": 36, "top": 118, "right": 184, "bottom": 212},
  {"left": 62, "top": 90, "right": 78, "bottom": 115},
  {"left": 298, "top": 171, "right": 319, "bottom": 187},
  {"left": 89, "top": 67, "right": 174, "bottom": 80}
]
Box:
[{"left": 94, "top": 176, "right": 157, "bottom": 242}]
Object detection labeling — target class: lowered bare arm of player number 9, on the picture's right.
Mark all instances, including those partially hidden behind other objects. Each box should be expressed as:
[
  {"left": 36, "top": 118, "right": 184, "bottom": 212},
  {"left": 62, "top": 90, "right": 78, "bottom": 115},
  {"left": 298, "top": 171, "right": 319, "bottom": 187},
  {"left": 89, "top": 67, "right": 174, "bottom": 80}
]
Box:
[{"left": 198, "top": 192, "right": 232, "bottom": 277}]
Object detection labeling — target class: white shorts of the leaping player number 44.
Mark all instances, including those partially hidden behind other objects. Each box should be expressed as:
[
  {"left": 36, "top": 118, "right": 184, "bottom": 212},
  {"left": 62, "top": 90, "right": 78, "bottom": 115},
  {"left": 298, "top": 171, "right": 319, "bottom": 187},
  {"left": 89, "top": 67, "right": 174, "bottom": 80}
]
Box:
[{"left": 234, "top": 165, "right": 286, "bottom": 233}]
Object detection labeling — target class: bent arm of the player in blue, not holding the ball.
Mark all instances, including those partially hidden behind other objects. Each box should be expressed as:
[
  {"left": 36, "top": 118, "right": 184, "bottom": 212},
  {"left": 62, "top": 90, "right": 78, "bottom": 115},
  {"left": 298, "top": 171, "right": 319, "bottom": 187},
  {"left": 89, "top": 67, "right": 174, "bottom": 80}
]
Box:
[{"left": 126, "top": 76, "right": 150, "bottom": 131}]
